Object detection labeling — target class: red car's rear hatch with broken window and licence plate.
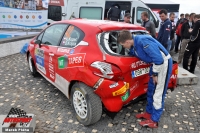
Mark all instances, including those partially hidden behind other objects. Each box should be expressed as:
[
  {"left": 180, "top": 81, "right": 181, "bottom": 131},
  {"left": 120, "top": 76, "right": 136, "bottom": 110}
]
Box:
[{"left": 98, "top": 30, "right": 177, "bottom": 102}]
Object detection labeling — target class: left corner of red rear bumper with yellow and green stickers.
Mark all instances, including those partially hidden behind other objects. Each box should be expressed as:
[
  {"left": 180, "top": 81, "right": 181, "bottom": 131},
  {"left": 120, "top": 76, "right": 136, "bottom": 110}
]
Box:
[{"left": 95, "top": 79, "right": 134, "bottom": 112}]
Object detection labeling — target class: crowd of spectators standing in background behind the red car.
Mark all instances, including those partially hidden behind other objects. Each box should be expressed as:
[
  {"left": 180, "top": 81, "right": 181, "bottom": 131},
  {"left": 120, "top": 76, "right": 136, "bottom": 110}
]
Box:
[{"left": 108, "top": 6, "right": 200, "bottom": 73}]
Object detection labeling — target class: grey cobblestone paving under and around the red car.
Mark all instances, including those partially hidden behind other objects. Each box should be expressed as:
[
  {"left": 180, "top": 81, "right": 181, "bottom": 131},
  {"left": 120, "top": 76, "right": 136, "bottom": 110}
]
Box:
[{"left": 0, "top": 54, "right": 200, "bottom": 133}]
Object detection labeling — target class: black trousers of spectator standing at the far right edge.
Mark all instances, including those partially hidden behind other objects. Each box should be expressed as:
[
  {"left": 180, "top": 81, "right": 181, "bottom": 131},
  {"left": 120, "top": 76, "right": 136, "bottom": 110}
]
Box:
[{"left": 183, "top": 42, "right": 200, "bottom": 73}]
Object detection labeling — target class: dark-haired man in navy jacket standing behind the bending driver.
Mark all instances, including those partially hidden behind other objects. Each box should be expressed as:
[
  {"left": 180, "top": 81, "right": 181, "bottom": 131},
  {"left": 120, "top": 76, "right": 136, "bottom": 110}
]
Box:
[{"left": 157, "top": 9, "right": 172, "bottom": 49}]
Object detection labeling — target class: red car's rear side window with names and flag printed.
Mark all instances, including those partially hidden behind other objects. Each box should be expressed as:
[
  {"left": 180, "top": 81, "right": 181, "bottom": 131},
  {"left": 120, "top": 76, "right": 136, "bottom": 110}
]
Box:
[{"left": 61, "top": 25, "right": 85, "bottom": 48}]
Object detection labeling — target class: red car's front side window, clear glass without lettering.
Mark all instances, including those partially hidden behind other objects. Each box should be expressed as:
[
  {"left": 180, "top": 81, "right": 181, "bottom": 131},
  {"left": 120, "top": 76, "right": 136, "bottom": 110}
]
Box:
[{"left": 42, "top": 24, "right": 68, "bottom": 46}]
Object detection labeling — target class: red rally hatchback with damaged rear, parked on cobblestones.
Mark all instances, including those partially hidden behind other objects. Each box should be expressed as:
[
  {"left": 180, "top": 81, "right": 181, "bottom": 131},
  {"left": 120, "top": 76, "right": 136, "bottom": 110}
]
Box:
[{"left": 27, "top": 19, "right": 178, "bottom": 125}]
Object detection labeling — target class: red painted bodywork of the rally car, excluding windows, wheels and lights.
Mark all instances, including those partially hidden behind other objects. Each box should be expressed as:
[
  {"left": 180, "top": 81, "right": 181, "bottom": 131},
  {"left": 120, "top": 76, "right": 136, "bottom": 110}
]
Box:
[{"left": 28, "top": 19, "right": 178, "bottom": 112}]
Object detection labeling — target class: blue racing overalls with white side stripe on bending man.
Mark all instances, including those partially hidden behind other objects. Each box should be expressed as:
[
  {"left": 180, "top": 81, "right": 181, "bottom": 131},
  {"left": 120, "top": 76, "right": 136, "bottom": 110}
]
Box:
[{"left": 129, "top": 35, "right": 173, "bottom": 122}]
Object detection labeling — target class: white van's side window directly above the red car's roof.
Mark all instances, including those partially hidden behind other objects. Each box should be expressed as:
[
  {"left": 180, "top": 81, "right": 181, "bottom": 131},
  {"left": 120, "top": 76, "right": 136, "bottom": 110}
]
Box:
[{"left": 79, "top": 7, "right": 103, "bottom": 20}]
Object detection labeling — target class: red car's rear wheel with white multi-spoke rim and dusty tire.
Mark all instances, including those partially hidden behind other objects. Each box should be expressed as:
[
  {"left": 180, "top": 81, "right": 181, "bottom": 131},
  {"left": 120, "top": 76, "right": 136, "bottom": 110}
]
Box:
[{"left": 70, "top": 82, "right": 102, "bottom": 126}]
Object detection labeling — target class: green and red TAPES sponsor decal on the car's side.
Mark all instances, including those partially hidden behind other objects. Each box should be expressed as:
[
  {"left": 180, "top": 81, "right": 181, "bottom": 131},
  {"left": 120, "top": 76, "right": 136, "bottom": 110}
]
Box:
[{"left": 58, "top": 53, "right": 86, "bottom": 69}]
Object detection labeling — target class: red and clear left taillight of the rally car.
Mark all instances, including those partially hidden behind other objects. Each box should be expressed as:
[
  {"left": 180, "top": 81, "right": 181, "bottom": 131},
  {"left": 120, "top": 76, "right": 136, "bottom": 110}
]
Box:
[{"left": 91, "top": 61, "right": 122, "bottom": 79}]
